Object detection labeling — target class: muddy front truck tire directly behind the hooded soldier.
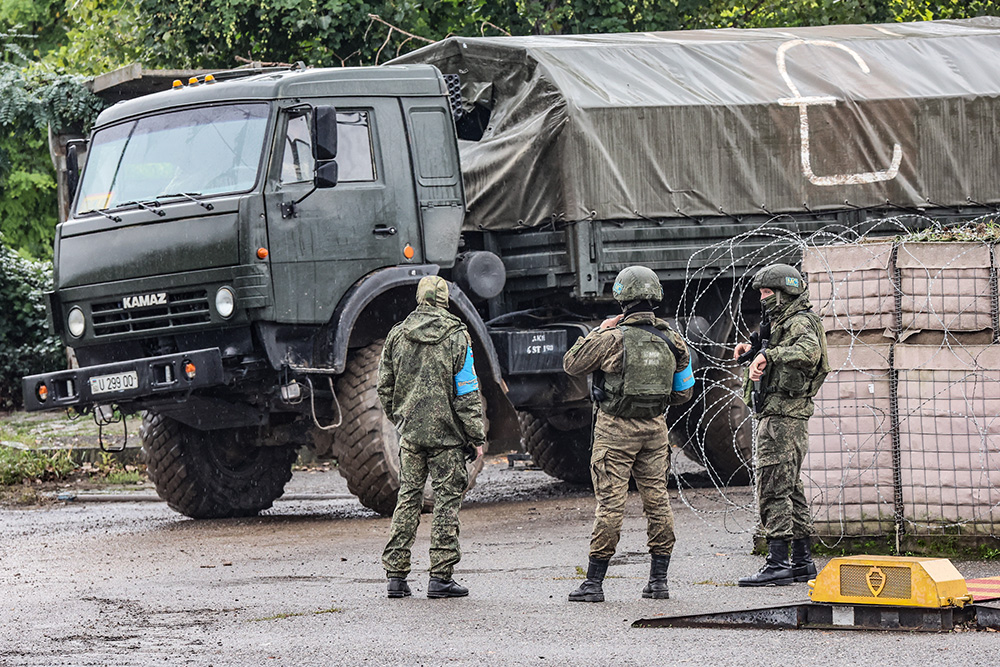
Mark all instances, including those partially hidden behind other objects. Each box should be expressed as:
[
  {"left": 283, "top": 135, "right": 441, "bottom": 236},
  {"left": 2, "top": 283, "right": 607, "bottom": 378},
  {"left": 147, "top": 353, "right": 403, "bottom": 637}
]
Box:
[{"left": 334, "top": 340, "right": 483, "bottom": 515}]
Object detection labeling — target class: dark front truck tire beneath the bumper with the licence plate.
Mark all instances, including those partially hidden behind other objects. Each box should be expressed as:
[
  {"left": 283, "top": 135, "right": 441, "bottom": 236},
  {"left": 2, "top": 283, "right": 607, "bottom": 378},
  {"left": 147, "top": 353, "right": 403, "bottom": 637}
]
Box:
[{"left": 139, "top": 412, "right": 296, "bottom": 519}]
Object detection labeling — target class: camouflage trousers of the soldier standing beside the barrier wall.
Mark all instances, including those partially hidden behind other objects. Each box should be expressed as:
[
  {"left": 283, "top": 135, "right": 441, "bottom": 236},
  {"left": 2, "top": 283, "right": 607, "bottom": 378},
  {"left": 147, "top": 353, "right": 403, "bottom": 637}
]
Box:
[{"left": 757, "top": 417, "right": 813, "bottom": 540}]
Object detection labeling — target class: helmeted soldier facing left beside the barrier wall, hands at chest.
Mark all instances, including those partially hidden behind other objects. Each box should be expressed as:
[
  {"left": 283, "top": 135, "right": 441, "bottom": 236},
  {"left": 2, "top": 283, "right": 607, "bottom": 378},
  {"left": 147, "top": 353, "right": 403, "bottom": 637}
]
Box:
[{"left": 733, "top": 264, "right": 830, "bottom": 586}]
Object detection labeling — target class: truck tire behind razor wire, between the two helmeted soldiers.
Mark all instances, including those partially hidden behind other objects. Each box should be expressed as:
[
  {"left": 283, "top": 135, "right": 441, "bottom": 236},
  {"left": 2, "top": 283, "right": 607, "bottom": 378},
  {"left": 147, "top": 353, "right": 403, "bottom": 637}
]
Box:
[{"left": 680, "top": 366, "right": 753, "bottom": 486}]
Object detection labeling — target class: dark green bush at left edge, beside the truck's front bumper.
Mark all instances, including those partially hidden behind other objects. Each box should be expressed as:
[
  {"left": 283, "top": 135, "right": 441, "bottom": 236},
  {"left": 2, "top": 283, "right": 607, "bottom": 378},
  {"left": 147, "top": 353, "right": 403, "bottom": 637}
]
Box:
[{"left": 0, "top": 235, "right": 64, "bottom": 408}]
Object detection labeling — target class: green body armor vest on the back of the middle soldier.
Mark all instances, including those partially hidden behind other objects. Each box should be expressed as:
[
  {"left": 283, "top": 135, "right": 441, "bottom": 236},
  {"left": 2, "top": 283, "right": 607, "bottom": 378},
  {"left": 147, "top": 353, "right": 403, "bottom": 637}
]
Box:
[{"left": 599, "top": 326, "right": 677, "bottom": 419}]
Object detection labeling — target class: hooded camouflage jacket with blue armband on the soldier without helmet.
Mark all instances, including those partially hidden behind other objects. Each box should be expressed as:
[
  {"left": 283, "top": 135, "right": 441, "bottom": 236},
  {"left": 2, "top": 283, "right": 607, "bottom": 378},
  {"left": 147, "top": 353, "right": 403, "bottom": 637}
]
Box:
[{"left": 378, "top": 304, "right": 486, "bottom": 447}]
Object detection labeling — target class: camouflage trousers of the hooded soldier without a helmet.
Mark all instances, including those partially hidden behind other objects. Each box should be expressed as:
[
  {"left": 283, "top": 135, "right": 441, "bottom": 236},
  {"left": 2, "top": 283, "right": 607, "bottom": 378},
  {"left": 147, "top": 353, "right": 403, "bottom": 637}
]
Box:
[{"left": 382, "top": 441, "right": 469, "bottom": 579}]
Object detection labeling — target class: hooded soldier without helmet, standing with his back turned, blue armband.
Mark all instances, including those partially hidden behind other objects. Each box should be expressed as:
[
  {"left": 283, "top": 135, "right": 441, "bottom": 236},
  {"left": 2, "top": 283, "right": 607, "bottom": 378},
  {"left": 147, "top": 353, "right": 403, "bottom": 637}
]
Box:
[{"left": 378, "top": 276, "right": 486, "bottom": 598}]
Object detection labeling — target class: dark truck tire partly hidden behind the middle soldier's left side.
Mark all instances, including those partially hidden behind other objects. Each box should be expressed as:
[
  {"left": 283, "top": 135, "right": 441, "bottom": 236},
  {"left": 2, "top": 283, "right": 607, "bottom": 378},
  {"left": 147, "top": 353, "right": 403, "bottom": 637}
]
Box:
[{"left": 517, "top": 412, "right": 592, "bottom": 486}]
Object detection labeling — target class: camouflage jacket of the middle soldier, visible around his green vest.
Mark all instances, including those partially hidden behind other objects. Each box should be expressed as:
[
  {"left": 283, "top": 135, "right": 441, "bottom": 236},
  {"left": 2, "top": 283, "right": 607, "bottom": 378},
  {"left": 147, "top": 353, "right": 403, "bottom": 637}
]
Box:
[{"left": 563, "top": 313, "right": 694, "bottom": 443}]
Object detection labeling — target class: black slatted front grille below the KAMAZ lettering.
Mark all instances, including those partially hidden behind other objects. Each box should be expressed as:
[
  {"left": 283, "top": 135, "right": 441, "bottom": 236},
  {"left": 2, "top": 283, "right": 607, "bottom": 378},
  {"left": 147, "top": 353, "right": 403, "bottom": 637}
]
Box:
[{"left": 90, "top": 290, "right": 212, "bottom": 336}]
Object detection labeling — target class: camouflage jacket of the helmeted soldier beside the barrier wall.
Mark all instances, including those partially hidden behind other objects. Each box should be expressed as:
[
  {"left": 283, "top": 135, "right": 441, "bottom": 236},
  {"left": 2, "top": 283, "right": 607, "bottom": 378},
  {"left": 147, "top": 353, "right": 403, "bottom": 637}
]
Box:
[{"left": 760, "top": 294, "right": 826, "bottom": 419}]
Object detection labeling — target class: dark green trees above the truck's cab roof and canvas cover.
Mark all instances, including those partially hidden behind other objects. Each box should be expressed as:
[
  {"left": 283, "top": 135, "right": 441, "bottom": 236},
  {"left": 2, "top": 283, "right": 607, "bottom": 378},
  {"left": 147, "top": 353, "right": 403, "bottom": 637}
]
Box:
[{"left": 129, "top": 0, "right": 1000, "bottom": 68}]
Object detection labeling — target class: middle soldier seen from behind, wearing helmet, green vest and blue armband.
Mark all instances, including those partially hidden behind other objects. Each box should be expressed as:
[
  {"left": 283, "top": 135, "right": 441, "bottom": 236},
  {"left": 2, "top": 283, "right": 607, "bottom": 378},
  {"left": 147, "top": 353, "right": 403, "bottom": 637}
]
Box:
[{"left": 563, "top": 266, "right": 694, "bottom": 602}]
